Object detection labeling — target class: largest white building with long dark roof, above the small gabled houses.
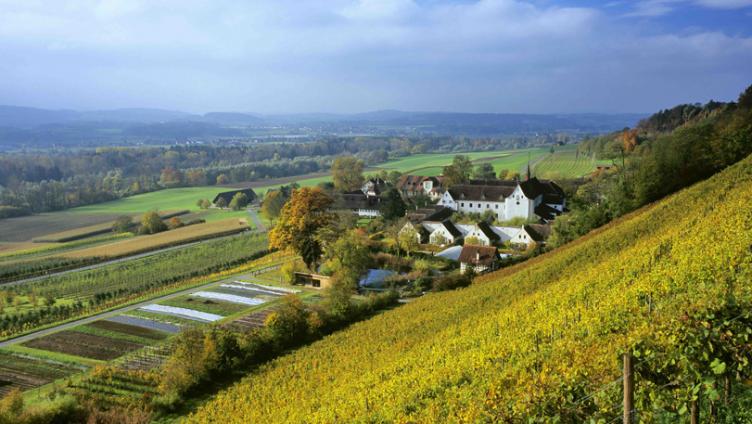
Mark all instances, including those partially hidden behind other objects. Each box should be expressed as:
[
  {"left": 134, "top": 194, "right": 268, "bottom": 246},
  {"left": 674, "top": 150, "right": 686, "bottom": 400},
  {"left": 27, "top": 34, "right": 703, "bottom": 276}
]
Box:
[{"left": 438, "top": 177, "right": 565, "bottom": 221}]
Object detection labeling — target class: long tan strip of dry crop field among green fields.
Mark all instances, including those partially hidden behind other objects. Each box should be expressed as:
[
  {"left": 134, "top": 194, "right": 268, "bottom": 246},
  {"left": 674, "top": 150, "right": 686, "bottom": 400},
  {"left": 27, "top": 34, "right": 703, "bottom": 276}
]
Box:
[{"left": 61, "top": 219, "right": 249, "bottom": 258}]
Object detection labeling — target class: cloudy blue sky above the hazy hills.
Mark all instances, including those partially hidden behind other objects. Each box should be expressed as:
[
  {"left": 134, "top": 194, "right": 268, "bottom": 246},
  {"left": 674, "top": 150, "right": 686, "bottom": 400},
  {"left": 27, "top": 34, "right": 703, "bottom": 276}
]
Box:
[{"left": 0, "top": 0, "right": 752, "bottom": 114}]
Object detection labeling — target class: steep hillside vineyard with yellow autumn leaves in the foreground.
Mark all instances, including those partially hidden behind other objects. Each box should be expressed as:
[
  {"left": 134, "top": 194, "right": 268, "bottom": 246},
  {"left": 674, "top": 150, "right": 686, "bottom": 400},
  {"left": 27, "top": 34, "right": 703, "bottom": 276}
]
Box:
[{"left": 187, "top": 152, "right": 752, "bottom": 423}]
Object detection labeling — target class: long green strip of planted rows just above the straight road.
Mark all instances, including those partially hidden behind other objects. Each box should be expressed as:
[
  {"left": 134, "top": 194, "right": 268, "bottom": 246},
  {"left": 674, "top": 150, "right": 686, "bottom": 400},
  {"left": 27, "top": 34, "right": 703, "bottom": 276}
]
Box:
[{"left": 0, "top": 234, "right": 271, "bottom": 337}]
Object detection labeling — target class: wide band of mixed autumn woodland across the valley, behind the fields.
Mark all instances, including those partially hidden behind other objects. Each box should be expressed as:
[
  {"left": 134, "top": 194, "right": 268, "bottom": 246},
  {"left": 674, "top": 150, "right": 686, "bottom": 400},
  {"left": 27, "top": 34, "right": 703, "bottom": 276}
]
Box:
[{"left": 0, "top": 137, "right": 548, "bottom": 218}]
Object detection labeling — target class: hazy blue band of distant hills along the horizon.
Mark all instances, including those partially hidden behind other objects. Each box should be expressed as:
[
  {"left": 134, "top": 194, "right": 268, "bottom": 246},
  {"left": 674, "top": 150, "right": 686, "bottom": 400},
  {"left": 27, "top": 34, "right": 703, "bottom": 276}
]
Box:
[{"left": 0, "top": 106, "right": 647, "bottom": 148}]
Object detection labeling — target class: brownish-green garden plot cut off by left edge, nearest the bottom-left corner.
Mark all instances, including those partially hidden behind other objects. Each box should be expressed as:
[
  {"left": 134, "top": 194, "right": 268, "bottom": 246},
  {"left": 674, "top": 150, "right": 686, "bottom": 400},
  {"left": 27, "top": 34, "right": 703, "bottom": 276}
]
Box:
[{"left": 0, "top": 351, "right": 86, "bottom": 397}]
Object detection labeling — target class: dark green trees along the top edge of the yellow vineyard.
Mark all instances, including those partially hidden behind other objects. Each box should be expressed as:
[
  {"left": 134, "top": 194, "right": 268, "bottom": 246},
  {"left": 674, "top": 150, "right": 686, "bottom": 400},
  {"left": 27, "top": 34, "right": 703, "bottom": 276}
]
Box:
[{"left": 549, "top": 86, "right": 752, "bottom": 246}]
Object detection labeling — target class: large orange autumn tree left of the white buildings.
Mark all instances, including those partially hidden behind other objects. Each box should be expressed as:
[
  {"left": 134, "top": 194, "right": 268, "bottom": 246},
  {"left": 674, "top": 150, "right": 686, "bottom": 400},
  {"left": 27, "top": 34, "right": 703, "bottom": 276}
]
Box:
[{"left": 269, "top": 187, "right": 334, "bottom": 269}]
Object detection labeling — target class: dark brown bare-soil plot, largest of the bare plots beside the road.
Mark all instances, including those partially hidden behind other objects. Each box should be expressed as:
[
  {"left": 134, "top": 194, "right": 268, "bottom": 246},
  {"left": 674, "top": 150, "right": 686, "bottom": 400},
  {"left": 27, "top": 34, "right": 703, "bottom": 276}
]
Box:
[{"left": 22, "top": 330, "right": 144, "bottom": 361}]
